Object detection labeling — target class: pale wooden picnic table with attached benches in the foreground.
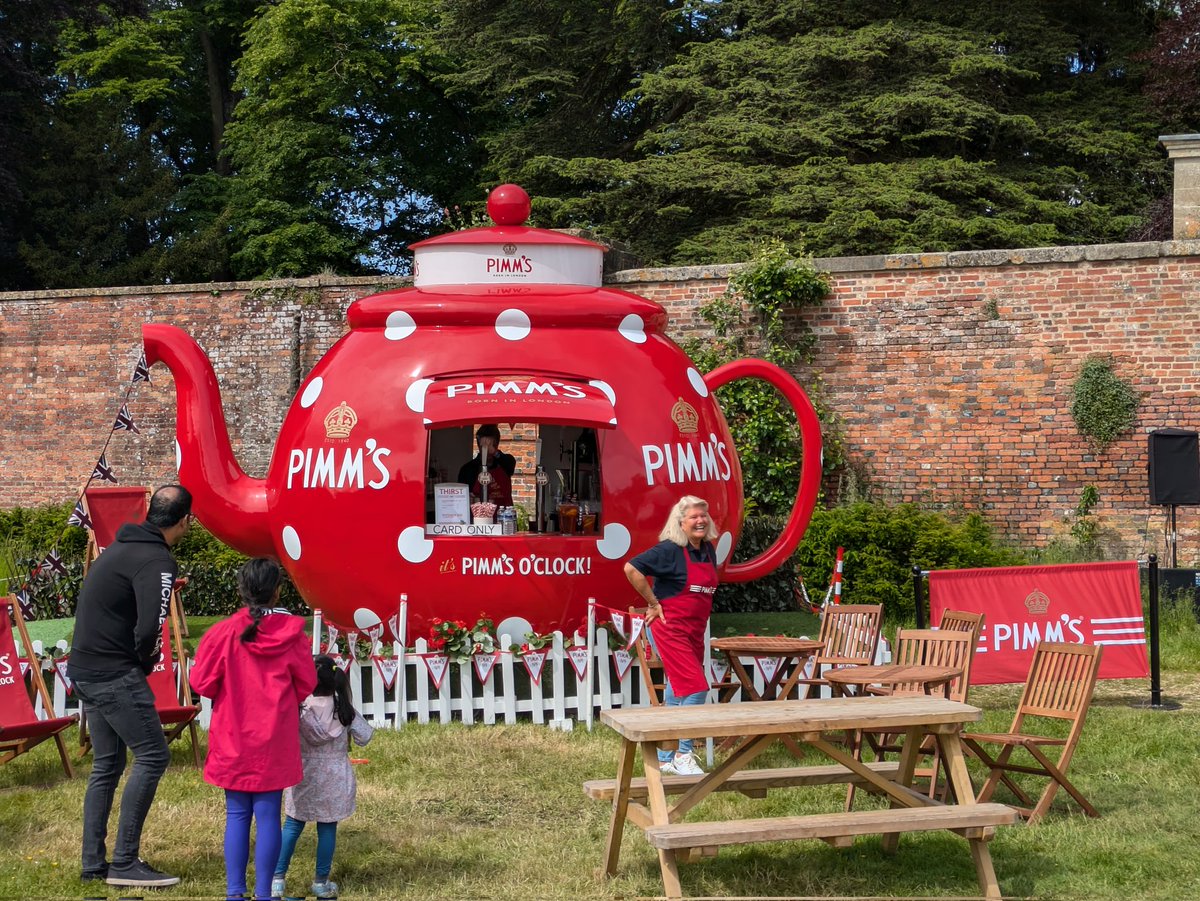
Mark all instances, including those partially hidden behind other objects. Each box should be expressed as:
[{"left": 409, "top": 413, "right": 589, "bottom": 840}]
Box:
[{"left": 584, "top": 696, "right": 1018, "bottom": 899}]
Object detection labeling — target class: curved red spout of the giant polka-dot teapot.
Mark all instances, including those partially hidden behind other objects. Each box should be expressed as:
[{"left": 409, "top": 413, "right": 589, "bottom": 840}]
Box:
[{"left": 142, "top": 323, "right": 276, "bottom": 557}]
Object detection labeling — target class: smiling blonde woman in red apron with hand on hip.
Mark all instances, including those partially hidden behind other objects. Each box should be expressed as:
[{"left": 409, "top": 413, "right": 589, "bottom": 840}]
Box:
[{"left": 625, "top": 494, "right": 716, "bottom": 776}]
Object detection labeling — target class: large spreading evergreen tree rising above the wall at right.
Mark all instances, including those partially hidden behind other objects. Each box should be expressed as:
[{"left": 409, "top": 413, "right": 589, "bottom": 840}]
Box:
[{"left": 493, "top": 0, "right": 1165, "bottom": 263}]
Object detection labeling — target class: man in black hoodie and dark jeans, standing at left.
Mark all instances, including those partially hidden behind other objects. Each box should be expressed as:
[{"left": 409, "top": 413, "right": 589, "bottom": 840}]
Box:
[{"left": 67, "top": 485, "right": 192, "bottom": 888}]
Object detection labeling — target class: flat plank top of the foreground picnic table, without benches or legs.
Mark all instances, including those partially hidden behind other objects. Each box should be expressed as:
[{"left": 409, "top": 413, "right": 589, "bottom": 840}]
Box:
[{"left": 600, "top": 696, "right": 983, "bottom": 741}]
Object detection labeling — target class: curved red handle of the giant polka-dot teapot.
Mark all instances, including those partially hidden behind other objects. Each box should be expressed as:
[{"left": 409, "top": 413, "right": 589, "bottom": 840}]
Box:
[{"left": 704, "top": 358, "right": 821, "bottom": 582}]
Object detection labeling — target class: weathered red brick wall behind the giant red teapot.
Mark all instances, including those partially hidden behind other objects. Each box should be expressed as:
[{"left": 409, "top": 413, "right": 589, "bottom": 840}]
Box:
[{"left": 0, "top": 242, "right": 1200, "bottom": 565}]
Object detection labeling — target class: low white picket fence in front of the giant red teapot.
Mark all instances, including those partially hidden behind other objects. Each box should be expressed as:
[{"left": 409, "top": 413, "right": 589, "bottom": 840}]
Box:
[{"left": 25, "top": 627, "right": 892, "bottom": 729}]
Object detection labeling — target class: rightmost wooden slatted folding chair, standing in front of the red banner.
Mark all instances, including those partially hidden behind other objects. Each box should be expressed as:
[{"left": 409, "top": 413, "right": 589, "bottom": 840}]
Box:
[{"left": 962, "top": 642, "right": 1102, "bottom": 823}]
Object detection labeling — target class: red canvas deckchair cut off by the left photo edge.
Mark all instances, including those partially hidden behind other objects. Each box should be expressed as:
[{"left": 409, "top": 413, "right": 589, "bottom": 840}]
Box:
[{"left": 0, "top": 597, "right": 79, "bottom": 779}]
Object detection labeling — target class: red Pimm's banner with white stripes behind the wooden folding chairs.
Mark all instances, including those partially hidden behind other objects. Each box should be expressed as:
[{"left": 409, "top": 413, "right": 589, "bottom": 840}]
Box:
[{"left": 929, "top": 560, "right": 1150, "bottom": 685}]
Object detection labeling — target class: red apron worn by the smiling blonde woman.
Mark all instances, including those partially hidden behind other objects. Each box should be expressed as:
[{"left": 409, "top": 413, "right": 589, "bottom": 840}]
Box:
[{"left": 650, "top": 547, "right": 716, "bottom": 698}]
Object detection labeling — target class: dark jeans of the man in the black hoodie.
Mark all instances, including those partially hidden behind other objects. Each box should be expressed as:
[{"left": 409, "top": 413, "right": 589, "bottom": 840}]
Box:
[{"left": 74, "top": 667, "right": 170, "bottom": 872}]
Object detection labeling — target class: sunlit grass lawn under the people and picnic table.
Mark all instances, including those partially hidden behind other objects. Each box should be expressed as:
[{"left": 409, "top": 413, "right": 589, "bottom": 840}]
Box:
[{"left": 0, "top": 609, "right": 1200, "bottom": 901}]
